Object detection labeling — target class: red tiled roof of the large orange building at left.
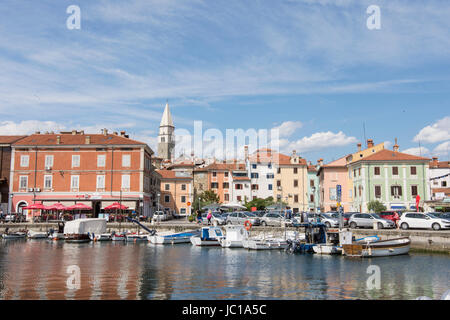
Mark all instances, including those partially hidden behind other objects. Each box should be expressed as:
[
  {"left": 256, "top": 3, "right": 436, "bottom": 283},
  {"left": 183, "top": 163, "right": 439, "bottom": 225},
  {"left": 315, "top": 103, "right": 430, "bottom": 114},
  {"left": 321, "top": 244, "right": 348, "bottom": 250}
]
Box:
[{"left": 14, "top": 133, "right": 146, "bottom": 146}]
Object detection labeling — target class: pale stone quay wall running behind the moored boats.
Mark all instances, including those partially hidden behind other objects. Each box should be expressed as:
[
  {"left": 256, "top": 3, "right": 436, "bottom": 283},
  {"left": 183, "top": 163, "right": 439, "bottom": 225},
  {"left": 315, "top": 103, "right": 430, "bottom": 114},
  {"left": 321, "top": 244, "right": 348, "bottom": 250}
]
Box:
[{"left": 0, "top": 222, "right": 450, "bottom": 254}]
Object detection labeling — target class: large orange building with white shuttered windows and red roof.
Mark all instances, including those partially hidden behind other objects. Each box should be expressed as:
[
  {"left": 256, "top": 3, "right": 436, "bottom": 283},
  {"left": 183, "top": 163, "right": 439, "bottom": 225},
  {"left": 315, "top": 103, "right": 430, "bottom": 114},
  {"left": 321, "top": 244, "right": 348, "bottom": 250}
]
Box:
[{"left": 10, "top": 129, "right": 159, "bottom": 216}]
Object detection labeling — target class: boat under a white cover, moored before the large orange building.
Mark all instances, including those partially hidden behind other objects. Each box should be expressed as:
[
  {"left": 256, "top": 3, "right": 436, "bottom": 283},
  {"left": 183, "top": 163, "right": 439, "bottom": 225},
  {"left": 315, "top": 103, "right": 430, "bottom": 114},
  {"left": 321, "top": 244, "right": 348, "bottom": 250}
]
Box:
[{"left": 64, "top": 218, "right": 106, "bottom": 243}]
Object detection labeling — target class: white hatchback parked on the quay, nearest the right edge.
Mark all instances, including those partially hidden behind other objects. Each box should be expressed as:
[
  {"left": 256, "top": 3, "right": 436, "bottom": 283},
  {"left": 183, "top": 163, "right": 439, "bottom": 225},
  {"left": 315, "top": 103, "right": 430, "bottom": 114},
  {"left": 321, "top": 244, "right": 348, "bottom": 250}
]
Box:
[{"left": 399, "top": 212, "right": 450, "bottom": 230}]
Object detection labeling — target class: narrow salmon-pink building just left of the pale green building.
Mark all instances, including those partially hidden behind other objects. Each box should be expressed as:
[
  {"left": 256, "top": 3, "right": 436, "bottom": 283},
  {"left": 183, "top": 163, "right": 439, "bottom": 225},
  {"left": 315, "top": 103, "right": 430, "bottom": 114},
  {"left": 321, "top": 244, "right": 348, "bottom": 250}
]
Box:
[{"left": 317, "top": 156, "right": 353, "bottom": 212}]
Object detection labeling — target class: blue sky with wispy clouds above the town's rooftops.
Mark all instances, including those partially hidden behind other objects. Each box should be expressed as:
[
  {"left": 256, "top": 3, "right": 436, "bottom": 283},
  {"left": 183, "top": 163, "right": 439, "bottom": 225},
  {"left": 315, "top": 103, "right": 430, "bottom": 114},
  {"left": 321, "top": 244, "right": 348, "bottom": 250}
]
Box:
[{"left": 0, "top": 0, "right": 450, "bottom": 162}]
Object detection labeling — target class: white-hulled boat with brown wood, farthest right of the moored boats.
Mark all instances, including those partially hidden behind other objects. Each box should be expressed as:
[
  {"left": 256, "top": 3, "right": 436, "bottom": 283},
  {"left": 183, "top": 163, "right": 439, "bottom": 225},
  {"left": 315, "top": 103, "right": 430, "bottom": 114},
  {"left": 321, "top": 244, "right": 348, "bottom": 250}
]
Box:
[{"left": 342, "top": 237, "right": 411, "bottom": 258}]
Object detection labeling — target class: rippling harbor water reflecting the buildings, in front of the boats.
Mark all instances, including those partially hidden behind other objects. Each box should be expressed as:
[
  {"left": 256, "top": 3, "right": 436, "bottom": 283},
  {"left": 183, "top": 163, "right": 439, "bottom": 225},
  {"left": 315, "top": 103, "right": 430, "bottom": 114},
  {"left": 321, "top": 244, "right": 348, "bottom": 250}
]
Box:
[{"left": 0, "top": 240, "right": 450, "bottom": 300}]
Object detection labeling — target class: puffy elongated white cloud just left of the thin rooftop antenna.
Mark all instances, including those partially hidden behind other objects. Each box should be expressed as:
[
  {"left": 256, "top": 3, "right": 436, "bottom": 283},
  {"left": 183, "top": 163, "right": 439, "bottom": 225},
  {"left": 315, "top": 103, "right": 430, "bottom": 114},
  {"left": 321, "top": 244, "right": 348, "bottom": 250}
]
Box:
[{"left": 289, "top": 131, "right": 358, "bottom": 153}]
